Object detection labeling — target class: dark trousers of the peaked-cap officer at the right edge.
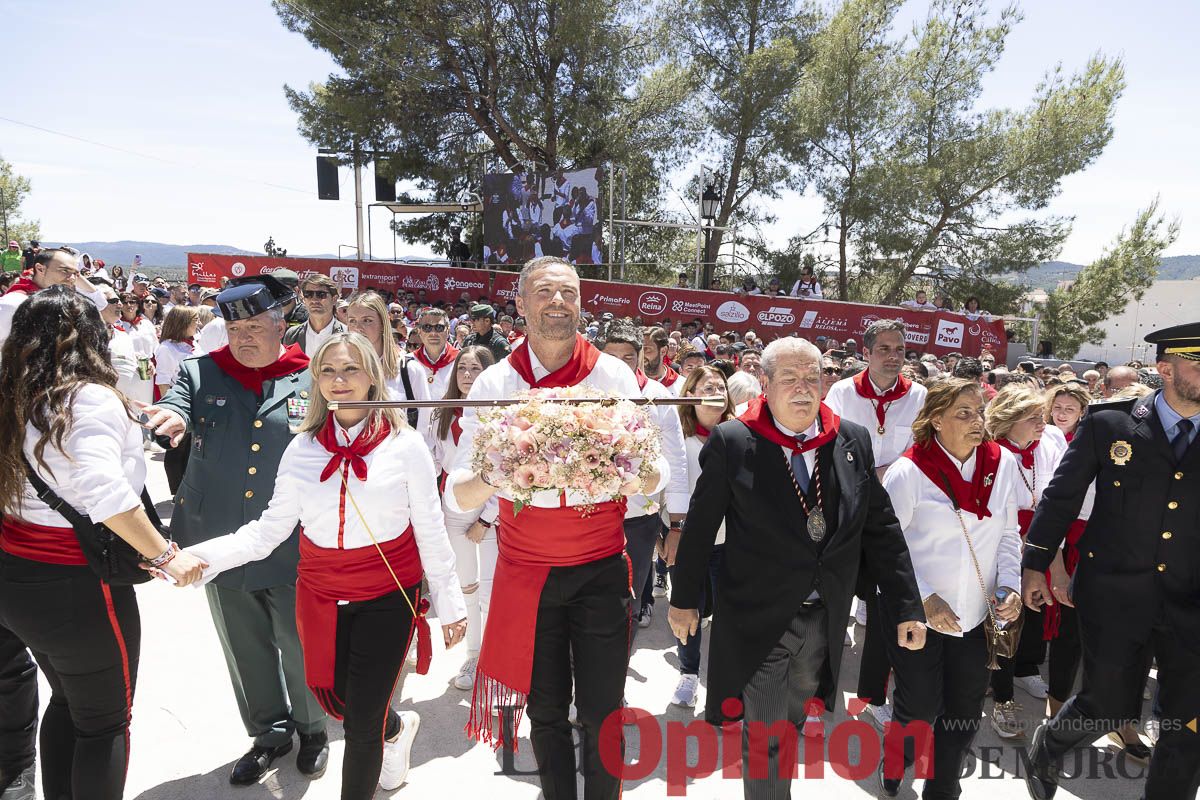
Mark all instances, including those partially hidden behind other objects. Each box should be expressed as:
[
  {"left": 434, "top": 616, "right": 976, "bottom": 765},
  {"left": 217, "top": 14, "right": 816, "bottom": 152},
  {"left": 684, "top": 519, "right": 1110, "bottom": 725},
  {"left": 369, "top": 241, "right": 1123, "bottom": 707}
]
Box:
[{"left": 1045, "top": 607, "right": 1200, "bottom": 800}]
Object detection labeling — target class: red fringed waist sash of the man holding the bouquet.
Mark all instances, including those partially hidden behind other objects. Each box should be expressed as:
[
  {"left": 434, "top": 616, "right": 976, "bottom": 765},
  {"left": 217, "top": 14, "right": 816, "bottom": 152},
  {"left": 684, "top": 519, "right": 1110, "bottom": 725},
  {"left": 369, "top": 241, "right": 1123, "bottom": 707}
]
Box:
[{"left": 467, "top": 499, "right": 625, "bottom": 747}]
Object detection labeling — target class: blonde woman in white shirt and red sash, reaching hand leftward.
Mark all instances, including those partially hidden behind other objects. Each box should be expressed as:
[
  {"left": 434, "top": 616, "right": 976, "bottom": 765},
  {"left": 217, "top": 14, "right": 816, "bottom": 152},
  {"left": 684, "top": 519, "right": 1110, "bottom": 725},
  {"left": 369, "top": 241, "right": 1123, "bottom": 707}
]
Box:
[{"left": 187, "top": 333, "right": 467, "bottom": 800}]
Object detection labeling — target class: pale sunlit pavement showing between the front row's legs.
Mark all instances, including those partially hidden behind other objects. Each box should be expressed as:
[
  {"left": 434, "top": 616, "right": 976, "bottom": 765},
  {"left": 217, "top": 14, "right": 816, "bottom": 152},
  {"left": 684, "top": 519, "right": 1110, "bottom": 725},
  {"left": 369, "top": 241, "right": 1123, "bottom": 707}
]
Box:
[{"left": 28, "top": 456, "right": 1144, "bottom": 800}]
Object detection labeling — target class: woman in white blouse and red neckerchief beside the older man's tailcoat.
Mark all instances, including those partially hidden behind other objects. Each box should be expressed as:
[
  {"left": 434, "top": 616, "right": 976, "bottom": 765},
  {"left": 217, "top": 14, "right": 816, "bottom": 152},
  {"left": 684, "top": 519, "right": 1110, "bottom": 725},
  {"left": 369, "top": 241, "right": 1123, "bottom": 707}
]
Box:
[{"left": 880, "top": 378, "right": 1021, "bottom": 798}]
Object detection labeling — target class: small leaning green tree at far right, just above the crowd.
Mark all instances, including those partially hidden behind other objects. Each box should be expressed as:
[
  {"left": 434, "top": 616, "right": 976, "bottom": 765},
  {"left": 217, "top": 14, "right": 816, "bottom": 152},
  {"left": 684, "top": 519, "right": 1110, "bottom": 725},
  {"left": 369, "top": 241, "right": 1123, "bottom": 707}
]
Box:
[{"left": 1038, "top": 199, "right": 1180, "bottom": 359}]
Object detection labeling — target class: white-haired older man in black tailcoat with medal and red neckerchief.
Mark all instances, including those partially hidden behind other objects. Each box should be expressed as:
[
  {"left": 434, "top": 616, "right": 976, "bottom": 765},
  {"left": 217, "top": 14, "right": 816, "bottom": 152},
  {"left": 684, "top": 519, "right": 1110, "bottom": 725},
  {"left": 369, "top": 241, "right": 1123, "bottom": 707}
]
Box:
[{"left": 667, "top": 338, "right": 925, "bottom": 800}]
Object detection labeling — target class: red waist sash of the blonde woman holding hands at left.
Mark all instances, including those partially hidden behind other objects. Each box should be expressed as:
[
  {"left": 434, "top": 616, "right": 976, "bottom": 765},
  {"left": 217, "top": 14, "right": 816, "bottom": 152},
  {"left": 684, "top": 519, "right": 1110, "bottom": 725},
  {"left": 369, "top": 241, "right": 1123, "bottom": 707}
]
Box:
[{"left": 296, "top": 525, "right": 433, "bottom": 720}]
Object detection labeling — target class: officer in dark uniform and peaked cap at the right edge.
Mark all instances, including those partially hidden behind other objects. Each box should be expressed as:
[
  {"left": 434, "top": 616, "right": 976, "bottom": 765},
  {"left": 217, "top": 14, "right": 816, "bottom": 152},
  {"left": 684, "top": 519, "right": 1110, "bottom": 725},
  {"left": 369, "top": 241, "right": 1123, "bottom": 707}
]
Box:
[{"left": 1022, "top": 323, "right": 1200, "bottom": 800}]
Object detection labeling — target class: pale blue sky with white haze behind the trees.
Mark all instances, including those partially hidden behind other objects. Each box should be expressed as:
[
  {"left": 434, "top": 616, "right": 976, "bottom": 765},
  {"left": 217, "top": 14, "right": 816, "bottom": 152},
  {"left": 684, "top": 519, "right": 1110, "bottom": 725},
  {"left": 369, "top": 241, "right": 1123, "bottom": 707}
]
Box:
[{"left": 0, "top": 0, "right": 1200, "bottom": 263}]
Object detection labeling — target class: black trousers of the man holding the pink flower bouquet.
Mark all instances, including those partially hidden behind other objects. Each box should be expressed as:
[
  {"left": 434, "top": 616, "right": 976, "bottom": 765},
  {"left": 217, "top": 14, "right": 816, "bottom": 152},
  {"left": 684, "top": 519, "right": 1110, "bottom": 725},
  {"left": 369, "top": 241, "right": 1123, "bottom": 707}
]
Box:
[{"left": 527, "top": 554, "right": 632, "bottom": 800}]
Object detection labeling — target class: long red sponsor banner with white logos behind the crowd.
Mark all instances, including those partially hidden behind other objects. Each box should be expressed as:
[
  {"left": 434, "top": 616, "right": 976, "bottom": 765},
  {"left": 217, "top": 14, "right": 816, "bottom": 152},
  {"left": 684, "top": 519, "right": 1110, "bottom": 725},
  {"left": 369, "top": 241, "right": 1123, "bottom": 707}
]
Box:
[{"left": 187, "top": 253, "right": 1008, "bottom": 363}]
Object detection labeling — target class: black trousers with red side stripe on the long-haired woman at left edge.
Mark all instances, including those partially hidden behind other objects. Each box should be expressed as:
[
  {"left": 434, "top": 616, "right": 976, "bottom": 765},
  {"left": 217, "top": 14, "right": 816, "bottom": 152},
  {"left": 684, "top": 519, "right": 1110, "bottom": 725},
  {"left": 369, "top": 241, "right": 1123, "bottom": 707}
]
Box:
[{"left": 0, "top": 553, "right": 142, "bottom": 800}]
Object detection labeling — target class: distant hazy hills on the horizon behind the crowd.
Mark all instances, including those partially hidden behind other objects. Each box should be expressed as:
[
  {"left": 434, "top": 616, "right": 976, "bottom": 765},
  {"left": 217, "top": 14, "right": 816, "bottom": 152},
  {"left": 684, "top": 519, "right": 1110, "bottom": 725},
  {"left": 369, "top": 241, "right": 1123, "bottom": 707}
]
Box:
[{"left": 46, "top": 241, "right": 1200, "bottom": 290}]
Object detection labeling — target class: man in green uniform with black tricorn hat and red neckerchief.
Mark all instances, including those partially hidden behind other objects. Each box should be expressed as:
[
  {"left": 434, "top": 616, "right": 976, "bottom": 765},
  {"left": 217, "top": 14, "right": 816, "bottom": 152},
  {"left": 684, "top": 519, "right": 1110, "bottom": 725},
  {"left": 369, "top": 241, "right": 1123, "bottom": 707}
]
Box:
[{"left": 146, "top": 276, "right": 329, "bottom": 786}]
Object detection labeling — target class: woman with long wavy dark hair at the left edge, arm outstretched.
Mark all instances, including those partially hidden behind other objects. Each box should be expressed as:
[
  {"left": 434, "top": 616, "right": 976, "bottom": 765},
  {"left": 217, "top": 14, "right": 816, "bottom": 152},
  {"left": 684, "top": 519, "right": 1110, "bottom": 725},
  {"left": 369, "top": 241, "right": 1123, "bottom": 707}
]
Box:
[{"left": 0, "top": 287, "right": 204, "bottom": 800}]
